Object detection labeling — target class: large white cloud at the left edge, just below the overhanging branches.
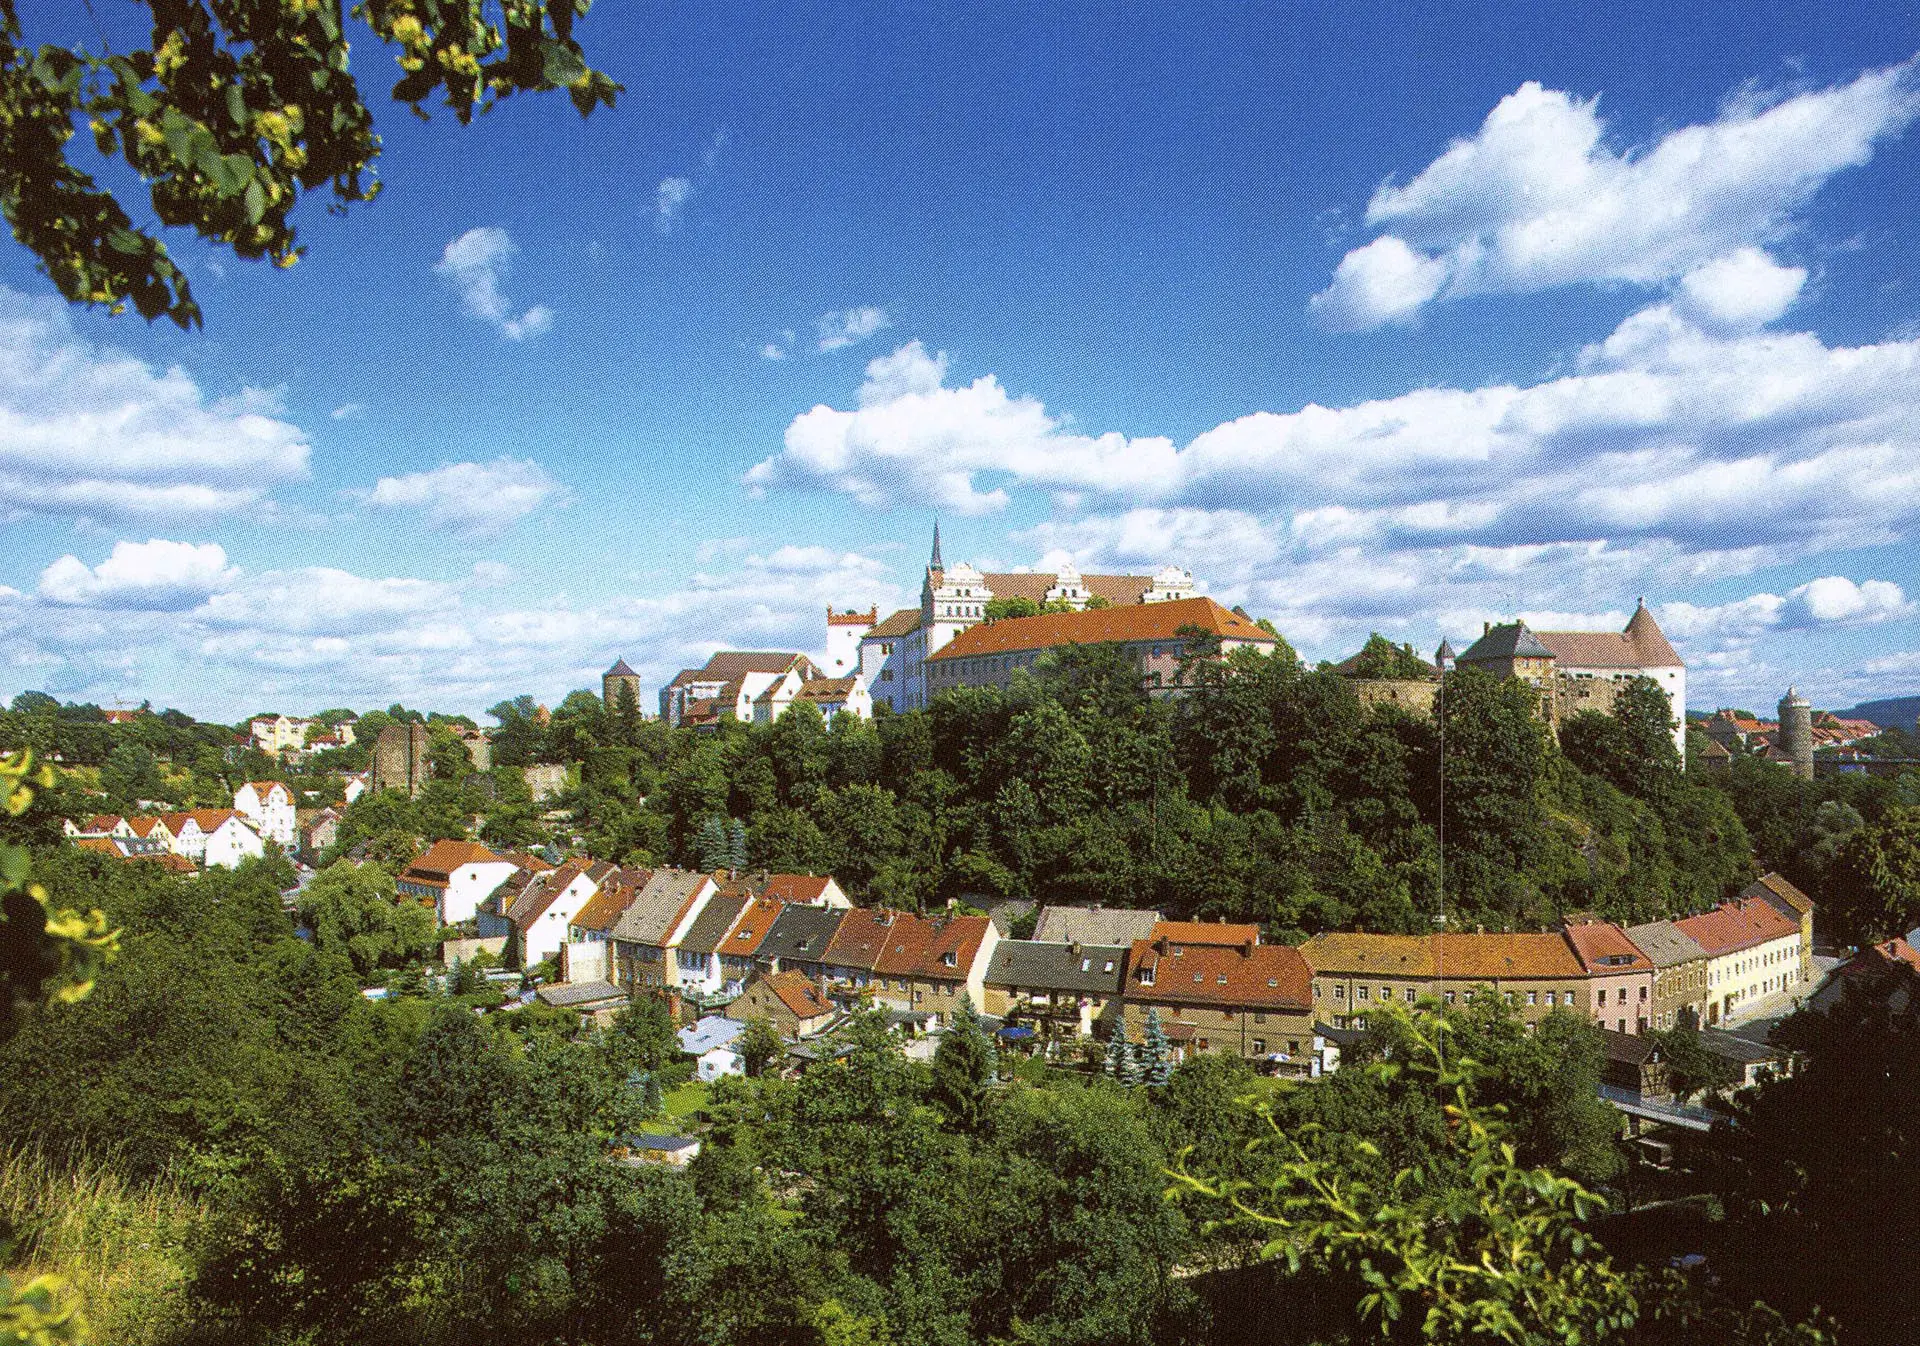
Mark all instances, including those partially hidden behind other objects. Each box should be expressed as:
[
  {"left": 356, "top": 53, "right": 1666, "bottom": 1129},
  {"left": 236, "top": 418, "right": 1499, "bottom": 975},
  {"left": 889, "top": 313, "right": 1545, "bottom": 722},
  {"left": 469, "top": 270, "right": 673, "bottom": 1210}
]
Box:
[{"left": 0, "top": 286, "right": 309, "bottom": 524}]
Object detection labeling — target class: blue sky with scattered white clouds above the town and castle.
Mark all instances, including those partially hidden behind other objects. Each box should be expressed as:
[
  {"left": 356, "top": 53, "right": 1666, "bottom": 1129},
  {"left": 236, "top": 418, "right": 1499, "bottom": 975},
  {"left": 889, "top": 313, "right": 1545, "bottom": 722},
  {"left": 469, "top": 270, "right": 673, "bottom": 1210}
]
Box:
[{"left": 0, "top": 4, "right": 1920, "bottom": 718}]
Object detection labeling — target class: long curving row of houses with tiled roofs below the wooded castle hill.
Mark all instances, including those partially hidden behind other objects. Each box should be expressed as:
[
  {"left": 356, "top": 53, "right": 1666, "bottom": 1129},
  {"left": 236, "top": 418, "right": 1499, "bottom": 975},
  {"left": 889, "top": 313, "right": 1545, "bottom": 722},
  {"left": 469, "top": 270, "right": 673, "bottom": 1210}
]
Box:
[{"left": 424, "top": 829, "right": 1812, "bottom": 1070}]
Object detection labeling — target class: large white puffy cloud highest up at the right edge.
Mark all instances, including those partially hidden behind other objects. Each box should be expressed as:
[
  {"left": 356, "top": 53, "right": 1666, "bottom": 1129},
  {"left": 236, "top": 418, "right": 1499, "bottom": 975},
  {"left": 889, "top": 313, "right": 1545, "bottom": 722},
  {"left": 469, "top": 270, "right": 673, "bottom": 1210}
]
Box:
[{"left": 1311, "top": 61, "right": 1920, "bottom": 328}]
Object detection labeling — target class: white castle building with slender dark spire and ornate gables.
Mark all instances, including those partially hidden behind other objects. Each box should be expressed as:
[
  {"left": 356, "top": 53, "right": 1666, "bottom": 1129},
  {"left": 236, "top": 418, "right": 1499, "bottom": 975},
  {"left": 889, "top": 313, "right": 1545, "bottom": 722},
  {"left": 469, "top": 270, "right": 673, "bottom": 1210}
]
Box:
[{"left": 840, "top": 524, "right": 1194, "bottom": 710}]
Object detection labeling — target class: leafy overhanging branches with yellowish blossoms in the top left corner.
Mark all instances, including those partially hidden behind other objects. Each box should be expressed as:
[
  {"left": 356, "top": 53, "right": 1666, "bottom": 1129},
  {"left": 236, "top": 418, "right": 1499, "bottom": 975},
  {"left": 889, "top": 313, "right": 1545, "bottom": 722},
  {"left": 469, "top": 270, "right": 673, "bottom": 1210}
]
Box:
[{"left": 0, "top": 0, "right": 618, "bottom": 328}]
